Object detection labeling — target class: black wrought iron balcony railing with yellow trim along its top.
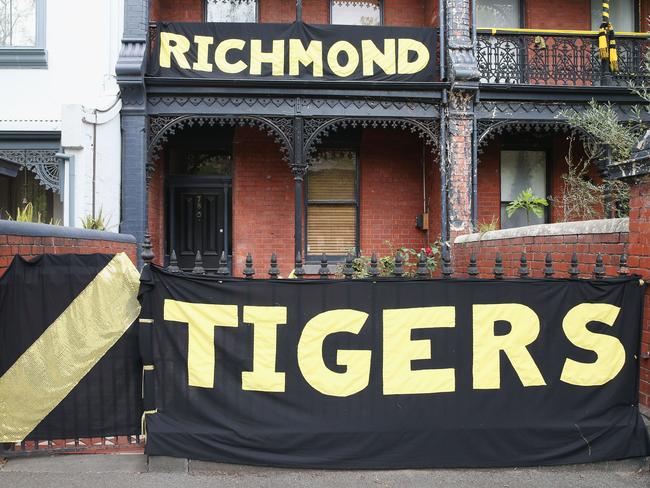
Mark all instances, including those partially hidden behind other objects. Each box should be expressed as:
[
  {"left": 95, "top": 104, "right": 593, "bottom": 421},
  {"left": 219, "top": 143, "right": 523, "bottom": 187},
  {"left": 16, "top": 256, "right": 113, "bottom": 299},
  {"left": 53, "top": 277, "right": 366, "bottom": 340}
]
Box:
[{"left": 476, "top": 29, "right": 650, "bottom": 86}]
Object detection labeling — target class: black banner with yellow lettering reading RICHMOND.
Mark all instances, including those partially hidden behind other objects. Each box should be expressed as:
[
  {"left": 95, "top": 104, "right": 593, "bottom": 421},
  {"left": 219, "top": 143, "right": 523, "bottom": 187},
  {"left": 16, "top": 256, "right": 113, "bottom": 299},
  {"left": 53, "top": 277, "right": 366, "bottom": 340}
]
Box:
[{"left": 149, "top": 22, "right": 438, "bottom": 82}]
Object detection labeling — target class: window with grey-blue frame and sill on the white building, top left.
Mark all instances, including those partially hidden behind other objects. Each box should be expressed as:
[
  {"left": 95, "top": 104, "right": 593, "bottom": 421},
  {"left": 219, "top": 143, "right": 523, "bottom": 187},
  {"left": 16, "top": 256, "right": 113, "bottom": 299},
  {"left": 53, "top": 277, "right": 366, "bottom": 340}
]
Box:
[{"left": 0, "top": 0, "right": 47, "bottom": 68}]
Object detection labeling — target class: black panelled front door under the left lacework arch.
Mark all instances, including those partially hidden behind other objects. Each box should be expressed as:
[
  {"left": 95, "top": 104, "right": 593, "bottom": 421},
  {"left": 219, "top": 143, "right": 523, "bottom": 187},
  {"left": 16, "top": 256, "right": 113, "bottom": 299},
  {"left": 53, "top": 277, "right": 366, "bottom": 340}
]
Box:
[{"left": 170, "top": 188, "right": 229, "bottom": 270}]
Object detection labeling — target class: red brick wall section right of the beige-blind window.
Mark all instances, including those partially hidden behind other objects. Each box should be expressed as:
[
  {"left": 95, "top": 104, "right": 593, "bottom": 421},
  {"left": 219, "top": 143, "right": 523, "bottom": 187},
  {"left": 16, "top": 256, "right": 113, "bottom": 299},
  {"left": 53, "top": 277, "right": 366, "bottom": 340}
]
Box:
[{"left": 359, "top": 129, "right": 432, "bottom": 255}]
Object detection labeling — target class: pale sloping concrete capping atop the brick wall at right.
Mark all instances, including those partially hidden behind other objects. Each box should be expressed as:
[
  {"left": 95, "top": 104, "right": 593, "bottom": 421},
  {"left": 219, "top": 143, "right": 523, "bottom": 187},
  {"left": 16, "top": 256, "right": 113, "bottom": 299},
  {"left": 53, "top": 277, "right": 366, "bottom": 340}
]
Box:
[{"left": 454, "top": 218, "right": 630, "bottom": 244}]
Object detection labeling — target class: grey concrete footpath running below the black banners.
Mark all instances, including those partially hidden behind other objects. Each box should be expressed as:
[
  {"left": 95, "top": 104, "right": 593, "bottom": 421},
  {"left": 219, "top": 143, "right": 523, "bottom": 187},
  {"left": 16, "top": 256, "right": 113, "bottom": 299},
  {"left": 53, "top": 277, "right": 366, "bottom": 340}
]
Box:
[{"left": 0, "top": 454, "right": 650, "bottom": 488}]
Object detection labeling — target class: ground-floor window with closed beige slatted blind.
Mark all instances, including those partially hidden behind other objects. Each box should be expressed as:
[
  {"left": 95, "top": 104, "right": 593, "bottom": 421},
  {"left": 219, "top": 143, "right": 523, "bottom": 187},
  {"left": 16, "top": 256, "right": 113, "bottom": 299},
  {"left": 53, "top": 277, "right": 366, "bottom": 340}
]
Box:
[{"left": 306, "top": 149, "right": 358, "bottom": 256}]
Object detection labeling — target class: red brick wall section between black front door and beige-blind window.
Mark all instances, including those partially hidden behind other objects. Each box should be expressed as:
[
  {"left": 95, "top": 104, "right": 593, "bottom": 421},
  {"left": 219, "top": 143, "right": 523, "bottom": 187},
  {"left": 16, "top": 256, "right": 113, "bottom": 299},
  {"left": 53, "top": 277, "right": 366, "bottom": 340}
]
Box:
[{"left": 232, "top": 127, "right": 295, "bottom": 277}]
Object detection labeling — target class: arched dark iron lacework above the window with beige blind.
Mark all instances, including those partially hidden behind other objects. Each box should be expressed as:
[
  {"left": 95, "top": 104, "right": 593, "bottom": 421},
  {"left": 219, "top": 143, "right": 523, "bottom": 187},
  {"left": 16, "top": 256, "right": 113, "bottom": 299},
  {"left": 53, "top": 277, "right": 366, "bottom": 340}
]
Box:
[{"left": 303, "top": 117, "right": 439, "bottom": 165}]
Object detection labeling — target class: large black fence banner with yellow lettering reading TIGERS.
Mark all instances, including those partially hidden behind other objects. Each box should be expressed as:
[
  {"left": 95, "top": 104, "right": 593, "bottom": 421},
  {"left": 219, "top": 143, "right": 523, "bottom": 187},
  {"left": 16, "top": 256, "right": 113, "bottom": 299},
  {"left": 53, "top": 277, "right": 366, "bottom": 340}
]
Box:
[{"left": 140, "top": 267, "right": 650, "bottom": 469}]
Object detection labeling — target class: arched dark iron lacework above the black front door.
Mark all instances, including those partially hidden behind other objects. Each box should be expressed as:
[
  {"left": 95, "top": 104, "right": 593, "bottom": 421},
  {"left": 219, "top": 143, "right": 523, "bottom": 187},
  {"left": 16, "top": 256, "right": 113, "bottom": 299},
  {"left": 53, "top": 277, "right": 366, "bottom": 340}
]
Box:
[{"left": 149, "top": 115, "right": 293, "bottom": 162}]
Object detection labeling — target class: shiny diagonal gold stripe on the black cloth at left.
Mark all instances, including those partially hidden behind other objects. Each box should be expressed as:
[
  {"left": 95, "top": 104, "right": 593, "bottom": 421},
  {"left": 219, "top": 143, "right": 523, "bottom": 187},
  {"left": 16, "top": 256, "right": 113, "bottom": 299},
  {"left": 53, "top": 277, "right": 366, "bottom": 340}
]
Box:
[{"left": 0, "top": 253, "right": 140, "bottom": 442}]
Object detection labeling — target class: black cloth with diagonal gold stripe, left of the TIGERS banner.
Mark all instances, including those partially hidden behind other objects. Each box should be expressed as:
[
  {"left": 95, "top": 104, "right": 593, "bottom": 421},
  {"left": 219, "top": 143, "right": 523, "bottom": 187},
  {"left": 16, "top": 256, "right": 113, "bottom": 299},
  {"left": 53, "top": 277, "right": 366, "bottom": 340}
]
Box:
[{"left": 0, "top": 253, "right": 142, "bottom": 444}]
